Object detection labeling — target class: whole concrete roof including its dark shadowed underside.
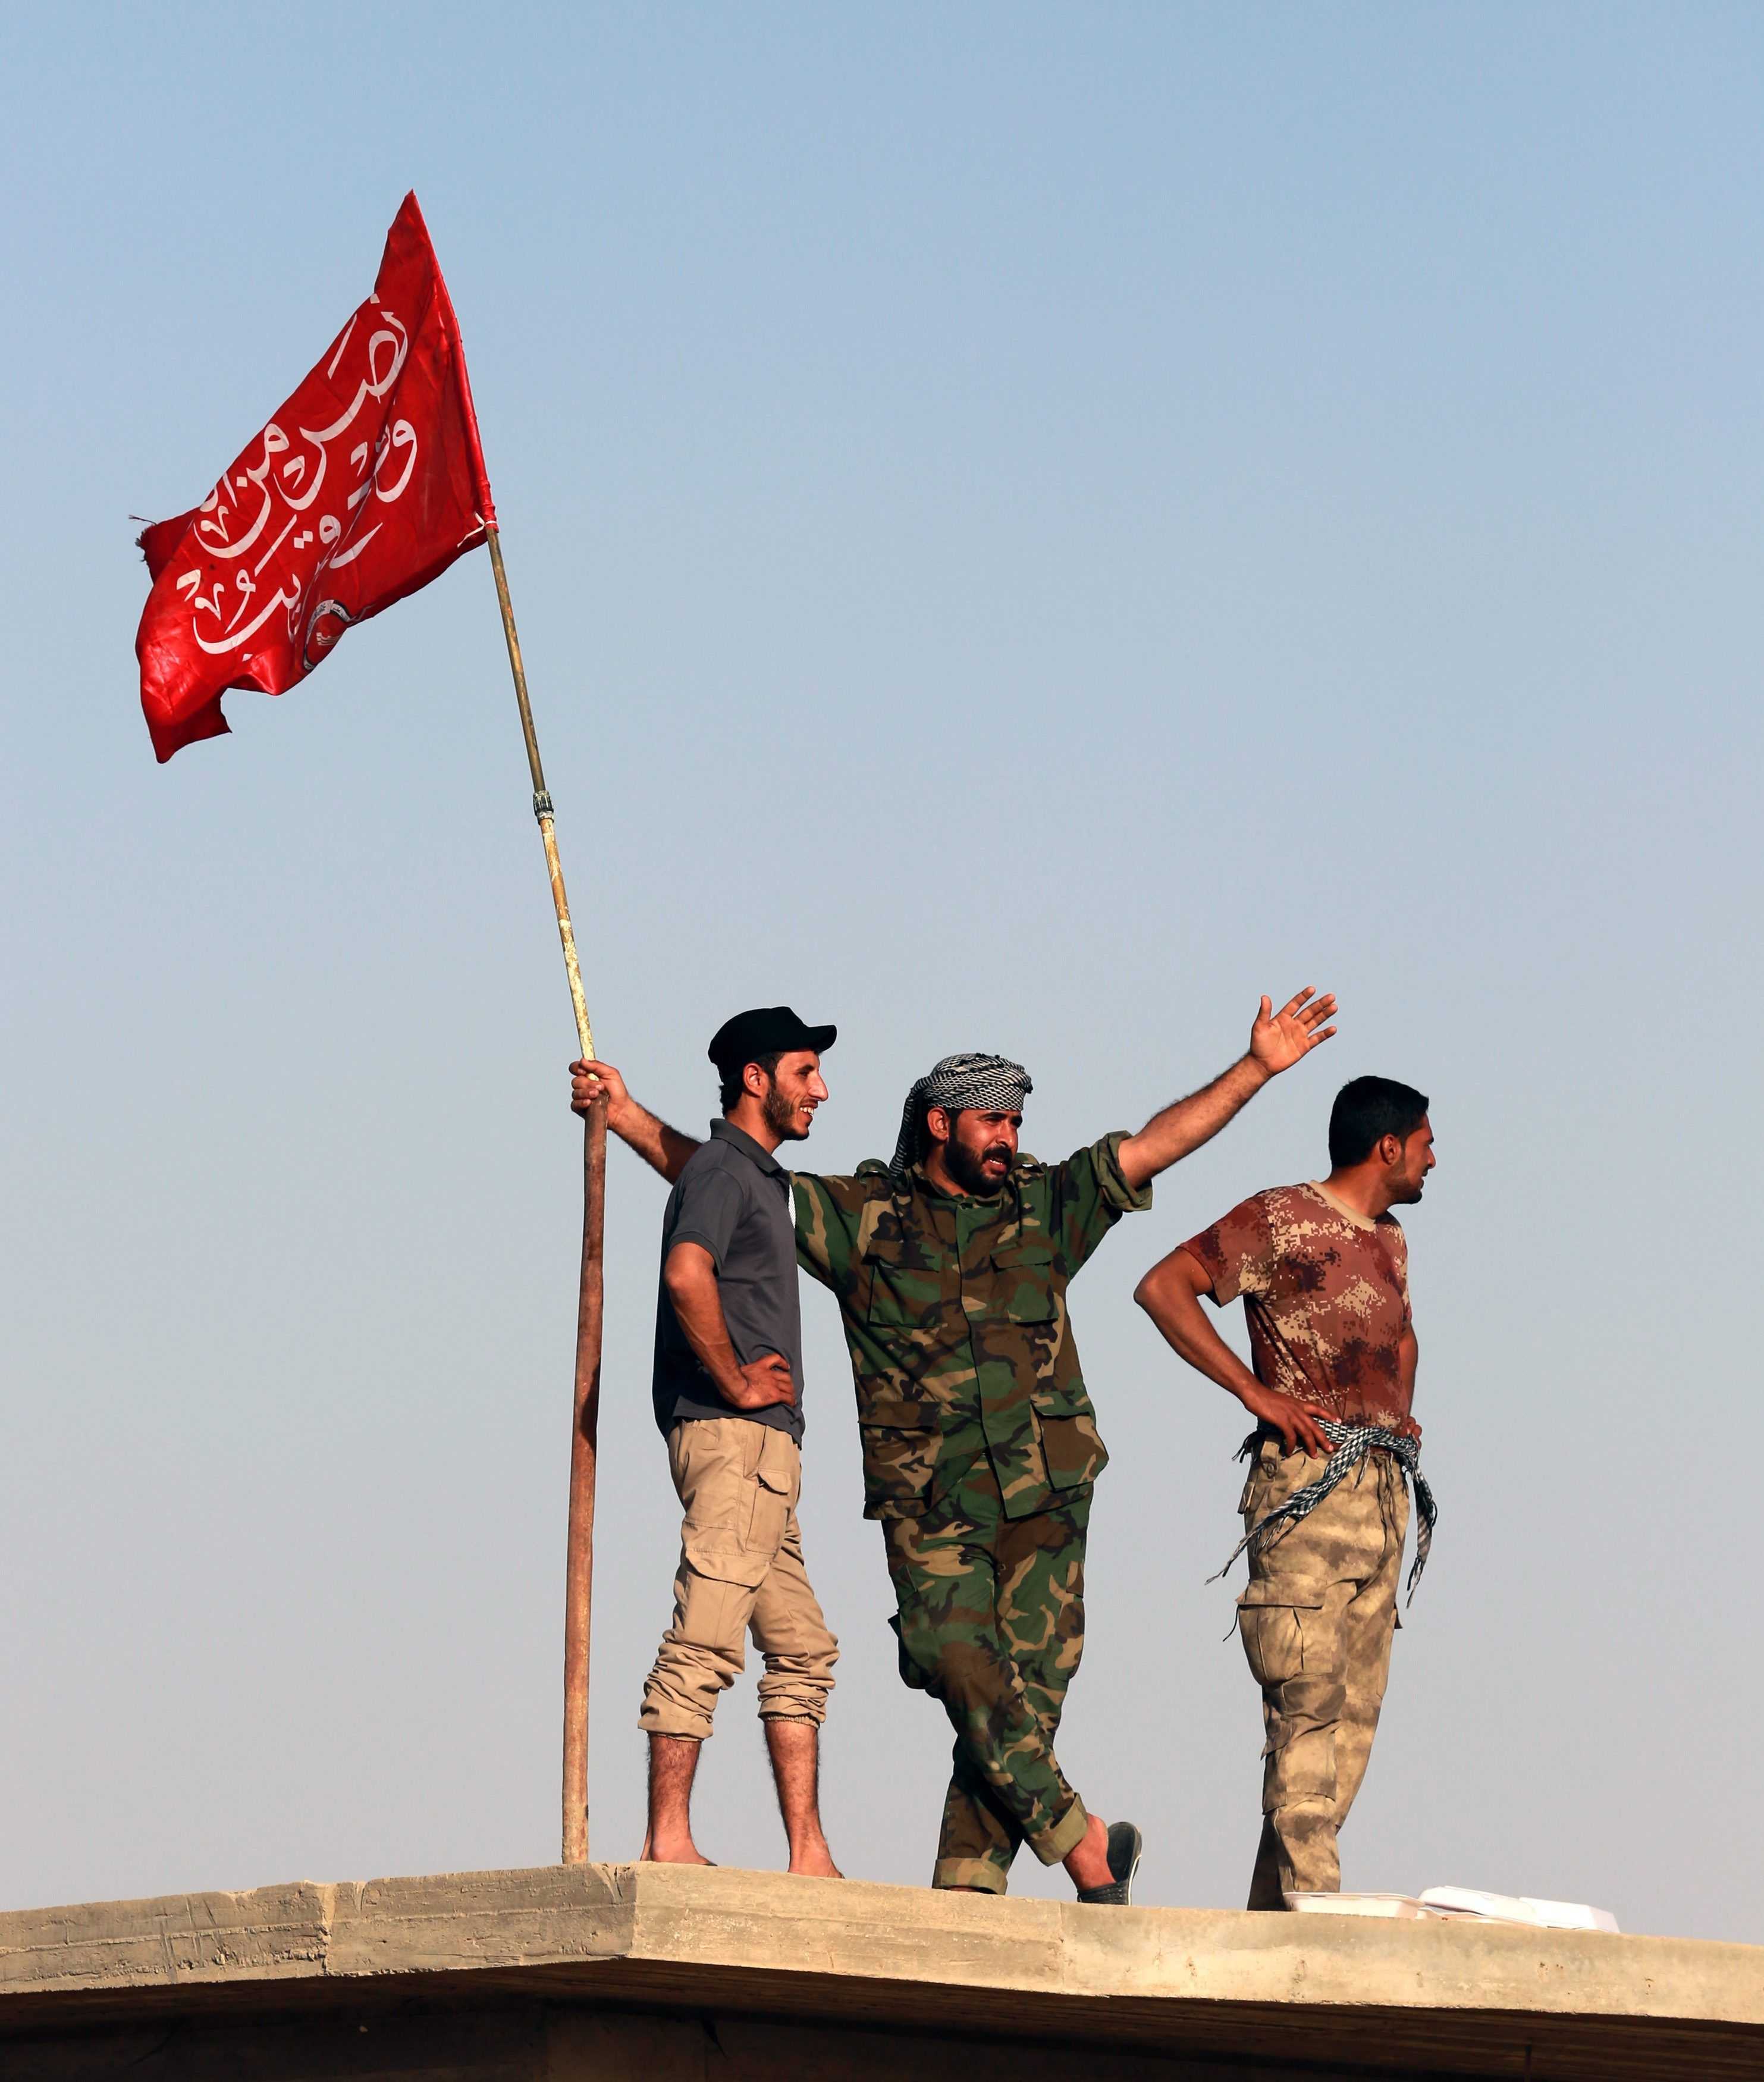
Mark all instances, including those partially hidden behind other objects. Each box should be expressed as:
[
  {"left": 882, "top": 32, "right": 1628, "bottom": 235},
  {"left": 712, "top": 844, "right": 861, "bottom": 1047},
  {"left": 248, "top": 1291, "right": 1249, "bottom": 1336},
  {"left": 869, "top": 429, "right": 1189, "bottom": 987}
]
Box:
[{"left": 0, "top": 1865, "right": 1764, "bottom": 2082}]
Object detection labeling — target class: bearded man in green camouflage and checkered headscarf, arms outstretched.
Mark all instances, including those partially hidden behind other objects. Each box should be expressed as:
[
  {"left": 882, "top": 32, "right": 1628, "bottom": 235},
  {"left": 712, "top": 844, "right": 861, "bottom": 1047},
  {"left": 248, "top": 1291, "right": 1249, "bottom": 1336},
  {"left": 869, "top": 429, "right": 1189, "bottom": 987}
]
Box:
[{"left": 573, "top": 989, "right": 1335, "bottom": 1903}]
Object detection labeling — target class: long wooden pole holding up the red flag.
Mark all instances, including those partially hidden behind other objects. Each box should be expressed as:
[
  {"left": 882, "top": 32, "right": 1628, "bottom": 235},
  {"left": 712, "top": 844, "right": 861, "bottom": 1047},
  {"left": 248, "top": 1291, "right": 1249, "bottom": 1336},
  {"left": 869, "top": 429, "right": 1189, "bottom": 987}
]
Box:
[{"left": 485, "top": 525, "right": 606, "bottom": 1865}]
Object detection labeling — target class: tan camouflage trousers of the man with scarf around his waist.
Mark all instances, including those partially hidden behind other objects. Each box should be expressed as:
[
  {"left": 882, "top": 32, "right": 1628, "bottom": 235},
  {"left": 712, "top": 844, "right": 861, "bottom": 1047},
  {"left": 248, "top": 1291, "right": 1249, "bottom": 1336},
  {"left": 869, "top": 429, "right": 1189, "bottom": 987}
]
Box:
[{"left": 1237, "top": 1441, "right": 1408, "bottom": 1909}]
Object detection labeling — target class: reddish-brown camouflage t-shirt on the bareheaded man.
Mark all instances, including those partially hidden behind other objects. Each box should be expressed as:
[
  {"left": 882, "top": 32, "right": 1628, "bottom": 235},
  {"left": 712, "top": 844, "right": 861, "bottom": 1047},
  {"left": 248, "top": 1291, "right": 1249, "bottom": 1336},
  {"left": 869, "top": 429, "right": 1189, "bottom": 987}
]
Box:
[{"left": 1183, "top": 1185, "right": 1410, "bottom": 1424}]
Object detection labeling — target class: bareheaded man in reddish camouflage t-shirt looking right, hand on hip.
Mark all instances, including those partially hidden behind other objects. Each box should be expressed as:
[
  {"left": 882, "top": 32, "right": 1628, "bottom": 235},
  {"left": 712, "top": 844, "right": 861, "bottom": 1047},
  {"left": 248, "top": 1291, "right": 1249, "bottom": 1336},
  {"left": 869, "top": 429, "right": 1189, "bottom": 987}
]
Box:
[{"left": 1135, "top": 1077, "right": 1435, "bottom": 1909}]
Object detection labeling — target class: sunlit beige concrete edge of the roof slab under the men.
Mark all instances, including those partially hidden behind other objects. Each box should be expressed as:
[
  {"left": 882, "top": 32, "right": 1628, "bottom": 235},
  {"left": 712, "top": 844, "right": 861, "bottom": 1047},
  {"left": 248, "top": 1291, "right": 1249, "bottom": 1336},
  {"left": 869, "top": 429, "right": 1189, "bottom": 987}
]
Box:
[{"left": 0, "top": 1865, "right": 1764, "bottom": 2026}]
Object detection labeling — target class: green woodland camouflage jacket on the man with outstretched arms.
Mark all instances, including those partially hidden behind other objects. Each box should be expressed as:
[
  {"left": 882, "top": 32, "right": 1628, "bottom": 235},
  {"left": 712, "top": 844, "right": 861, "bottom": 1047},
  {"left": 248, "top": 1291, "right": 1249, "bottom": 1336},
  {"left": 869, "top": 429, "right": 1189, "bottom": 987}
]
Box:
[{"left": 793, "top": 1131, "right": 1151, "bottom": 1518}]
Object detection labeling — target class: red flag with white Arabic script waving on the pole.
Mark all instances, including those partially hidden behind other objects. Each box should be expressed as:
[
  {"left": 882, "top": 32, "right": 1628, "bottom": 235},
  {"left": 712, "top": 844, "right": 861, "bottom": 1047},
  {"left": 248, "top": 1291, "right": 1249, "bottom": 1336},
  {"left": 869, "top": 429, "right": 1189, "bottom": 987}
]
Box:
[{"left": 136, "top": 196, "right": 495, "bottom": 762}]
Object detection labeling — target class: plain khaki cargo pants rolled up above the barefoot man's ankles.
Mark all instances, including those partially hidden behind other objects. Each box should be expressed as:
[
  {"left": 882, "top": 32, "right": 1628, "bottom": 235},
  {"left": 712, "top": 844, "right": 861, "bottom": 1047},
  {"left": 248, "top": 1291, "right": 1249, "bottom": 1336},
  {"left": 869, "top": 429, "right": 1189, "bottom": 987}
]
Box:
[{"left": 638, "top": 1418, "right": 839, "bottom": 1743}]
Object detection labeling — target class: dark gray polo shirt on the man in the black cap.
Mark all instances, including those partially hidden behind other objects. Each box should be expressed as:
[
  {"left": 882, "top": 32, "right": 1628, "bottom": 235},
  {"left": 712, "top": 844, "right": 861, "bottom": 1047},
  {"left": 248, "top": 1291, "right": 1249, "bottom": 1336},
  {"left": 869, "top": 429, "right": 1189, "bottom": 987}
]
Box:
[{"left": 654, "top": 1120, "right": 802, "bottom": 1443}]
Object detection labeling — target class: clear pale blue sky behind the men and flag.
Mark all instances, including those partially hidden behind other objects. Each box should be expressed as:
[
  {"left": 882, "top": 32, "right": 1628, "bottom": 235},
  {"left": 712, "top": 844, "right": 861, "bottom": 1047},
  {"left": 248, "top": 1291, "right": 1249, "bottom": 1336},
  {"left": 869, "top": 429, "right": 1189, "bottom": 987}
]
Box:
[{"left": 0, "top": 4, "right": 1764, "bottom": 1940}]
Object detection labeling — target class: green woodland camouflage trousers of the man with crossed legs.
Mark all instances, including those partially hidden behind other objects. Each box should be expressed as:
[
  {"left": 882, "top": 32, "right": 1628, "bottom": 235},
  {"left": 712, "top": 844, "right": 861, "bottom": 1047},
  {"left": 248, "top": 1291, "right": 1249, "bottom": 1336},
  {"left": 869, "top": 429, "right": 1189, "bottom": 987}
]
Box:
[{"left": 883, "top": 1460, "right": 1091, "bottom": 1895}]
